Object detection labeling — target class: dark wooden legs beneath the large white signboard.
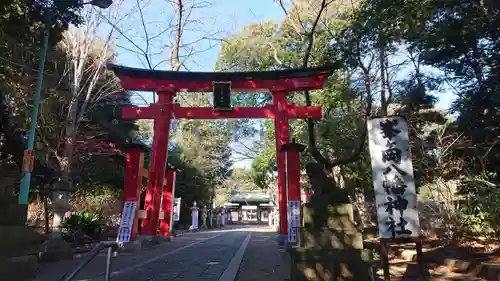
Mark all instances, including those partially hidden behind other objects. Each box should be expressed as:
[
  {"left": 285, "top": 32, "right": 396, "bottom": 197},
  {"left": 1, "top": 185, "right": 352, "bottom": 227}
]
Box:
[{"left": 380, "top": 237, "right": 427, "bottom": 281}]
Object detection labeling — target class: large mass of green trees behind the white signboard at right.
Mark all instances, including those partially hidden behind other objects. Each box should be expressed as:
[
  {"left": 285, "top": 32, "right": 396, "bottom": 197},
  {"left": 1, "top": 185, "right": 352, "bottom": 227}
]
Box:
[{"left": 214, "top": 0, "right": 500, "bottom": 236}]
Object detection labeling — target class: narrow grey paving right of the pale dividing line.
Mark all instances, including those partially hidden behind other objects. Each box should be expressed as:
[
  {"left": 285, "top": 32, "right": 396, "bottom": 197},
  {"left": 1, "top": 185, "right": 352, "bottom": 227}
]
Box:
[{"left": 235, "top": 227, "right": 290, "bottom": 281}]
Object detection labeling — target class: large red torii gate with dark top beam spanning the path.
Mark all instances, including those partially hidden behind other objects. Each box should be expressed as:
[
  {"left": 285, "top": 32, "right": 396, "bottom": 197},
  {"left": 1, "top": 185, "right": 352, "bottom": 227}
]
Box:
[{"left": 108, "top": 65, "right": 333, "bottom": 238}]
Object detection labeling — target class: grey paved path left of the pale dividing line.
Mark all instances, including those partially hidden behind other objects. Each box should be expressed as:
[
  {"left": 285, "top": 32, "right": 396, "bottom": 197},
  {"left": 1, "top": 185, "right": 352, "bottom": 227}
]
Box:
[{"left": 32, "top": 226, "right": 254, "bottom": 281}]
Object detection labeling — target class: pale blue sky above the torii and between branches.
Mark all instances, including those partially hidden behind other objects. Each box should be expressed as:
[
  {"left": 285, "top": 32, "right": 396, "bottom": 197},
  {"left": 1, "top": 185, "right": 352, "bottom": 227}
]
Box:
[{"left": 107, "top": 0, "right": 452, "bottom": 167}]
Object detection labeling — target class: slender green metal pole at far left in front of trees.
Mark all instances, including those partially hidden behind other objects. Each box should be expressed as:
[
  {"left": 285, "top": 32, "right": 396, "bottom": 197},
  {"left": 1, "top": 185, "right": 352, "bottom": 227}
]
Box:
[{"left": 19, "top": 14, "right": 51, "bottom": 205}]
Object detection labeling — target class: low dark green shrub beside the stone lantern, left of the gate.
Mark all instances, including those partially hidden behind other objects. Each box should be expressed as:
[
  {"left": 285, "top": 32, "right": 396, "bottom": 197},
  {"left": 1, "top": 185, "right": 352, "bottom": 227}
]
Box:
[{"left": 62, "top": 212, "right": 106, "bottom": 236}]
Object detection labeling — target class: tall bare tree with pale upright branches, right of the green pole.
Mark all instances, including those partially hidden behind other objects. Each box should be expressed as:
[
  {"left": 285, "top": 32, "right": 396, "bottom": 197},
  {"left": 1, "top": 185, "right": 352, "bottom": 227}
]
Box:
[{"left": 56, "top": 3, "right": 124, "bottom": 186}]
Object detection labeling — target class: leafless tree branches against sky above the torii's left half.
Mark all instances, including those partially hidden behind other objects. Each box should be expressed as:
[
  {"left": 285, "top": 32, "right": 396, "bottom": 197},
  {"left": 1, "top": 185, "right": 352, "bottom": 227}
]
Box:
[{"left": 102, "top": 0, "right": 221, "bottom": 107}]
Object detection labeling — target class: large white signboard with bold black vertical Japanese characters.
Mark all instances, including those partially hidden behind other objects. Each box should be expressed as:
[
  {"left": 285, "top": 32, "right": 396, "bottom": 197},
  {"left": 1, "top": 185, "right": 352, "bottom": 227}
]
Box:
[{"left": 367, "top": 116, "right": 420, "bottom": 238}]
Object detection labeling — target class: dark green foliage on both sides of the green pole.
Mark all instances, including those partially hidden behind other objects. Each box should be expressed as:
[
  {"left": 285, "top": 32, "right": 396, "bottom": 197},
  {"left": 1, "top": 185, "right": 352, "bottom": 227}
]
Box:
[{"left": 0, "top": 0, "right": 99, "bottom": 206}]
